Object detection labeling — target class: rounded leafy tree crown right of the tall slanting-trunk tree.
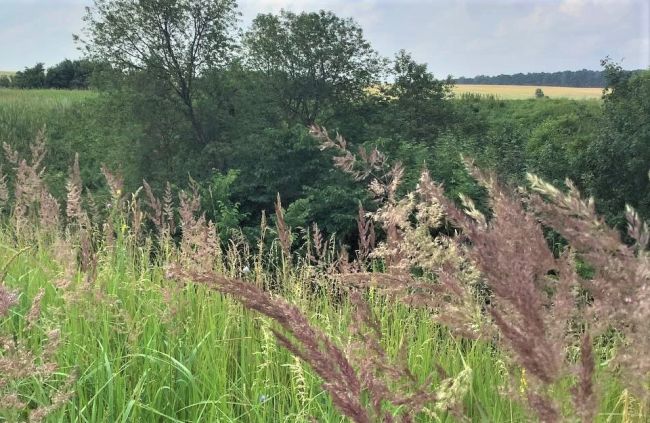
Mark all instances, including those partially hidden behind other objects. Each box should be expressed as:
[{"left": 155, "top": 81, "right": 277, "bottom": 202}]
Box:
[{"left": 244, "top": 11, "right": 384, "bottom": 125}]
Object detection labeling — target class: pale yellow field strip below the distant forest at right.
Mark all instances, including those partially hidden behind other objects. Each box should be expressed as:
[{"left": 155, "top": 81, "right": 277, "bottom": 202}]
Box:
[{"left": 454, "top": 84, "right": 603, "bottom": 100}]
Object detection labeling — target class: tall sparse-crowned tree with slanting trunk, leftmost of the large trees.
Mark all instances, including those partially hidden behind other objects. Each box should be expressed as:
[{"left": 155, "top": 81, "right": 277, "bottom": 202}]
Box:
[{"left": 75, "top": 0, "right": 238, "bottom": 145}]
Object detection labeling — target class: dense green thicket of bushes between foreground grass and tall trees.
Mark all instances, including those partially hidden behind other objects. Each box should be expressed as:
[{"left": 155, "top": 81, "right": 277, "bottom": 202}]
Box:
[{"left": 0, "top": 62, "right": 650, "bottom": 245}]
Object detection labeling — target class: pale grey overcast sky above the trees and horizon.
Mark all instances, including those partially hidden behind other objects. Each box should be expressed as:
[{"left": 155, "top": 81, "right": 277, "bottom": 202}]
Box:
[{"left": 0, "top": 0, "right": 650, "bottom": 77}]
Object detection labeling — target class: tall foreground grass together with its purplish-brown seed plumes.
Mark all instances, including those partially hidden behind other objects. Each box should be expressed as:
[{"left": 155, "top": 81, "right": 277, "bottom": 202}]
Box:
[{"left": 0, "top": 132, "right": 648, "bottom": 422}]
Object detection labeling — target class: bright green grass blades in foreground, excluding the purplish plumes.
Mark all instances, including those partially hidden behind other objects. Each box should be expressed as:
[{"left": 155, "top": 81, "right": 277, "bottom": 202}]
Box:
[{"left": 0, "top": 225, "right": 647, "bottom": 422}]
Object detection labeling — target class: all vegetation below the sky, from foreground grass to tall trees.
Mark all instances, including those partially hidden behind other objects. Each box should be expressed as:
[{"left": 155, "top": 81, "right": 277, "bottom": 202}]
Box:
[{"left": 0, "top": 0, "right": 650, "bottom": 422}]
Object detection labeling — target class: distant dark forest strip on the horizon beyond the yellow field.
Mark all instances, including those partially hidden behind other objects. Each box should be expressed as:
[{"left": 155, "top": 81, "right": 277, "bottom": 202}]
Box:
[{"left": 456, "top": 69, "right": 639, "bottom": 88}]
